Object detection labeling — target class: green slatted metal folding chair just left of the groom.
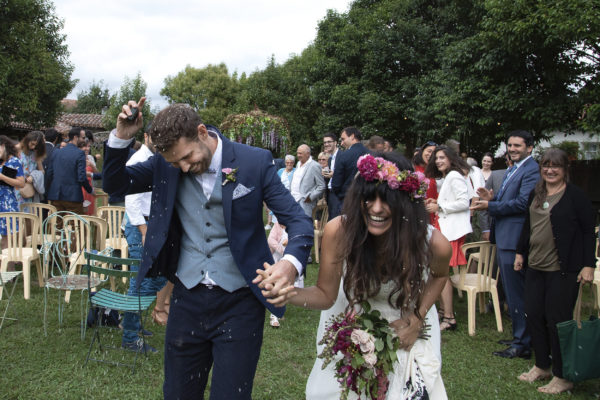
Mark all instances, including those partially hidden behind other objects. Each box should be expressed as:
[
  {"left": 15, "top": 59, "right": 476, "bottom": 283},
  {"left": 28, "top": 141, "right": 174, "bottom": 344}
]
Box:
[{"left": 84, "top": 252, "right": 156, "bottom": 373}]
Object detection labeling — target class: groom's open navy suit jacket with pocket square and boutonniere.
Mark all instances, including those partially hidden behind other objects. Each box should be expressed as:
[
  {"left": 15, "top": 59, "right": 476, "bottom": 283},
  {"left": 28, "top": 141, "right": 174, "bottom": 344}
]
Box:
[{"left": 103, "top": 126, "right": 313, "bottom": 316}]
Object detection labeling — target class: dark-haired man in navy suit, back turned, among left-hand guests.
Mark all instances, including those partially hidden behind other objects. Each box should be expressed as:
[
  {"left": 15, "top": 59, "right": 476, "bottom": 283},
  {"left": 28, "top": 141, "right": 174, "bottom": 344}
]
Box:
[{"left": 45, "top": 127, "right": 93, "bottom": 214}]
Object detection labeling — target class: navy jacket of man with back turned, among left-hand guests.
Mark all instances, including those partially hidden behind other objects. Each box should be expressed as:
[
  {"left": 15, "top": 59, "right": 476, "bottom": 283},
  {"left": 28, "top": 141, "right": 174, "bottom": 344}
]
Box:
[{"left": 45, "top": 143, "right": 92, "bottom": 203}]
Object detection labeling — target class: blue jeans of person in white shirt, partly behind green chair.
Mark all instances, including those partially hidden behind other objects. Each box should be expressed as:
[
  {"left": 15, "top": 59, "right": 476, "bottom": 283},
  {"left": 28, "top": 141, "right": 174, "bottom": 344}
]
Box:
[{"left": 122, "top": 217, "right": 167, "bottom": 343}]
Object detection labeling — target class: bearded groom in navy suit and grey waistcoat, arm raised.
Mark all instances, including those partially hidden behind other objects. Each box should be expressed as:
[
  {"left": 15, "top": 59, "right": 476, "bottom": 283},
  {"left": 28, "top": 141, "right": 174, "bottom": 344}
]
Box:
[{"left": 103, "top": 98, "right": 313, "bottom": 399}]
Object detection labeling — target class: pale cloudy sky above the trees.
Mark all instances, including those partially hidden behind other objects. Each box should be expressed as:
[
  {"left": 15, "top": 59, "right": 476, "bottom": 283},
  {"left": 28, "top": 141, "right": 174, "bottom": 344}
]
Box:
[{"left": 54, "top": 0, "right": 351, "bottom": 108}]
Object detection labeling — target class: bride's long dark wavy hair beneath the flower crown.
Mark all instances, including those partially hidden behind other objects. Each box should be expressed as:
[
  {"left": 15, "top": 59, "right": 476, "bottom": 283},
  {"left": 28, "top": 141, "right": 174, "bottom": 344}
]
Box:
[{"left": 339, "top": 153, "right": 431, "bottom": 319}]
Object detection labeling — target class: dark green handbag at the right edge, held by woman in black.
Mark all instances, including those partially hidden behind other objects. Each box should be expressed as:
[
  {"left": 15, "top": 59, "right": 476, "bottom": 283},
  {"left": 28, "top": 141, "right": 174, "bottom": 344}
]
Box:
[{"left": 556, "top": 285, "right": 600, "bottom": 382}]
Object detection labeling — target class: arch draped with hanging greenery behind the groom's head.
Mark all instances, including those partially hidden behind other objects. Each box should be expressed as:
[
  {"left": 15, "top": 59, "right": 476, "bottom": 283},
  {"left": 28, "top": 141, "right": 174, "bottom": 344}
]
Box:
[{"left": 220, "top": 109, "right": 290, "bottom": 157}]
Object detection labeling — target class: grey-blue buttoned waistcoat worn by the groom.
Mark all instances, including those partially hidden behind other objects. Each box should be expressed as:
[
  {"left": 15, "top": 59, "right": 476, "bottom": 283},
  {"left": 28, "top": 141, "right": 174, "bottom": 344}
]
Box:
[{"left": 176, "top": 172, "right": 247, "bottom": 292}]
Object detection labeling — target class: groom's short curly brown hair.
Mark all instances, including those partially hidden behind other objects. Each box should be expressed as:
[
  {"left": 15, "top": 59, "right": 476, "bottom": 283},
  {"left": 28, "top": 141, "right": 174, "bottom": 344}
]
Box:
[{"left": 148, "top": 103, "right": 202, "bottom": 152}]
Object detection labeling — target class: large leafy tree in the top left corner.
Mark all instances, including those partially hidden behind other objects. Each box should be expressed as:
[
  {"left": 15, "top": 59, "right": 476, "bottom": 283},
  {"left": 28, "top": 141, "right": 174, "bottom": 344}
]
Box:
[{"left": 0, "top": 0, "right": 76, "bottom": 128}]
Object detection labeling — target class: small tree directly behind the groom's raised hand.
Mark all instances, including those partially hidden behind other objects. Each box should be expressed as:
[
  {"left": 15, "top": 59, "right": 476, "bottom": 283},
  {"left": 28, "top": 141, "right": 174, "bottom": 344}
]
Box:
[{"left": 102, "top": 72, "right": 154, "bottom": 141}]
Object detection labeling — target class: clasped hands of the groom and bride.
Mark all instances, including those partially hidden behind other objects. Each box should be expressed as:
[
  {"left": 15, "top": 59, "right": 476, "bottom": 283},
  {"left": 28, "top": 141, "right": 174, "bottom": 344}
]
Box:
[{"left": 252, "top": 259, "right": 298, "bottom": 307}]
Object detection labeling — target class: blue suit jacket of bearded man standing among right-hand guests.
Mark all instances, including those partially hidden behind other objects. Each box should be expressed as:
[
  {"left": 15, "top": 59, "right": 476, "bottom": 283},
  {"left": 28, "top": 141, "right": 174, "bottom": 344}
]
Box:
[{"left": 488, "top": 158, "right": 540, "bottom": 250}]
